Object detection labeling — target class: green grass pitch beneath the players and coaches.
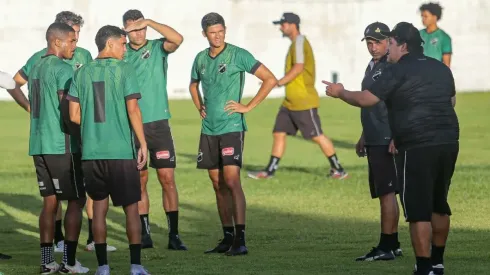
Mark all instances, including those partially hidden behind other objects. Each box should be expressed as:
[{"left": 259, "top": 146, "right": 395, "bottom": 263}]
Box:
[{"left": 0, "top": 93, "right": 490, "bottom": 275}]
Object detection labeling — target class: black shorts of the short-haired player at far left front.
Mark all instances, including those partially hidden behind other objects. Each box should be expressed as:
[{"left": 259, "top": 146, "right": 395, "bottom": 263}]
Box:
[{"left": 33, "top": 154, "right": 85, "bottom": 200}]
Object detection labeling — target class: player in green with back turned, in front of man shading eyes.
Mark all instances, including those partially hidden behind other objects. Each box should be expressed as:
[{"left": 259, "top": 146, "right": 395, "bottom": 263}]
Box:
[{"left": 68, "top": 26, "right": 148, "bottom": 275}]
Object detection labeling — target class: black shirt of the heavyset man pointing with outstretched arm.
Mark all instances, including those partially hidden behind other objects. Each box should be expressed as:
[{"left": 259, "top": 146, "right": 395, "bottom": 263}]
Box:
[{"left": 369, "top": 53, "right": 459, "bottom": 150}]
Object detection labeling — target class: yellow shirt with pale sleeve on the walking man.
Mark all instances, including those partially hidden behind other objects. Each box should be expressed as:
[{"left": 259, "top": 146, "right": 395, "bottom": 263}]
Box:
[{"left": 282, "top": 35, "right": 320, "bottom": 111}]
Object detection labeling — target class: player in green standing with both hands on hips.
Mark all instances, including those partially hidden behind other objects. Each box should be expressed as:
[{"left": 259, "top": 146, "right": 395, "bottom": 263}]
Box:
[{"left": 189, "top": 13, "right": 277, "bottom": 256}]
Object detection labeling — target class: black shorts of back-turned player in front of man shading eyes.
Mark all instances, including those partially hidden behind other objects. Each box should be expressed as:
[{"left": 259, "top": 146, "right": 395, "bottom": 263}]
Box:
[{"left": 82, "top": 159, "right": 141, "bottom": 206}]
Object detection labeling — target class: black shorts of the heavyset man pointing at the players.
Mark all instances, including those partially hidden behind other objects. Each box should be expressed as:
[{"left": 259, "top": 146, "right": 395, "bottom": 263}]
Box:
[{"left": 398, "top": 144, "right": 459, "bottom": 222}]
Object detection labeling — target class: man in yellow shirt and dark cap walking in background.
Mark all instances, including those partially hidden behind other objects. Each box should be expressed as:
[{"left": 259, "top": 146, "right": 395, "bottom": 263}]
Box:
[{"left": 248, "top": 12, "right": 348, "bottom": 179}]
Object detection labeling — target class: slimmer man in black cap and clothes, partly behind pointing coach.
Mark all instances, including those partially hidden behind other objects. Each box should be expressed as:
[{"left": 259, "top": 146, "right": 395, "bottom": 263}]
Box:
[{"left": 356, "top": 22, "right": 402, "bottom": 261}]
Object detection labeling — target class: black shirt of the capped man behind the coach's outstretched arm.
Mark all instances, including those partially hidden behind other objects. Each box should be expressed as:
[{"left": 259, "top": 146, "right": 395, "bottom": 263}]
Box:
[{"left": 361, "top": 55, "right": 391, "bottom": 146}]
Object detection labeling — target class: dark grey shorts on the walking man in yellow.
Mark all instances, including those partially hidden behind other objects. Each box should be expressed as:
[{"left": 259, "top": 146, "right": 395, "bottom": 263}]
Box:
[{"left": 273, "top": 106, "right": 323, "bottom": 139}]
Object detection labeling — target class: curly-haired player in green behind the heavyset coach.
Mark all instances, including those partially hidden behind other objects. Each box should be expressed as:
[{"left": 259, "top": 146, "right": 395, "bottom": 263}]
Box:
[{"left": 419, "top": 3, "right": 453, "bottom": 67}]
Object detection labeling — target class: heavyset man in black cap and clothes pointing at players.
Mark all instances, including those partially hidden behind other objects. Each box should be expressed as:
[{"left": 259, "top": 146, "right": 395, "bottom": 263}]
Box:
[{"left": 323, "top": 22, "right": 459, "bottom": 275}]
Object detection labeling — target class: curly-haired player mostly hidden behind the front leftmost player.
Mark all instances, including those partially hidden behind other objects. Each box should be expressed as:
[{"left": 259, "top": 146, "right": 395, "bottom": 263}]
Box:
[{"left": 5, "top": 11, "right": 116, "bottom": 253}]
